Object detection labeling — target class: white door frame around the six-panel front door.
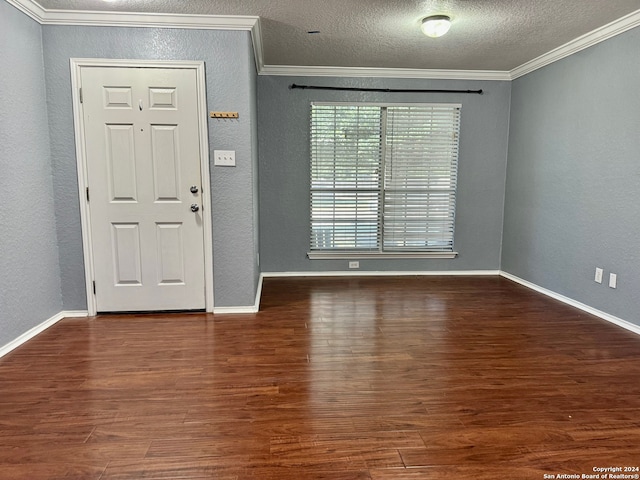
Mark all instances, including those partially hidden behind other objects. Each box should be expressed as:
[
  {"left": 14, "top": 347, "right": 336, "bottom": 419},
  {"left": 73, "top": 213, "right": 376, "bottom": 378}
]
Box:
[{"left": 71, "top": 58, "right": 213, "bottom": 316}]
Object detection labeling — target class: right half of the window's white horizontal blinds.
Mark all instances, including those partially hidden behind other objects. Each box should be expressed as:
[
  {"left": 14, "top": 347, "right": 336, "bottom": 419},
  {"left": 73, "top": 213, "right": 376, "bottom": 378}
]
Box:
[{"left": 383, "top": 105, "right": 460, "bottom": 251}]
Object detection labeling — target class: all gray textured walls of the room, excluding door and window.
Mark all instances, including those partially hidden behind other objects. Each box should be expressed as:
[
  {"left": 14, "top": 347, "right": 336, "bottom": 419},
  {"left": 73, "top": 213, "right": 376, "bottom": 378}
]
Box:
[{"left": 0, "top": 2, "right": 640, "bottom": 346}]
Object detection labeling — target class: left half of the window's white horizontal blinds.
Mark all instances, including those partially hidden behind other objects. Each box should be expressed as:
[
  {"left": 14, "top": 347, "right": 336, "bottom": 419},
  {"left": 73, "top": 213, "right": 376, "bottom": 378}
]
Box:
[{"left": 311, "top": 105, "right": 382, "bottom": 250}]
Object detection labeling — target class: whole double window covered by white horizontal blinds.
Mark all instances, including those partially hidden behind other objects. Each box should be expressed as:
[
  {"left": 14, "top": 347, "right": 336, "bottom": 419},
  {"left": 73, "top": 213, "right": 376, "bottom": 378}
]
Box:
[{"left": 309, "top": 104, "right": 461, "bottom": 258}]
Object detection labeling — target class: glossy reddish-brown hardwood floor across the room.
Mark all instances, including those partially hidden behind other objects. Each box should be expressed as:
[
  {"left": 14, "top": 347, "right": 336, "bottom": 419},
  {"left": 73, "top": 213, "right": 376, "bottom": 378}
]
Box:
[{"left": 0, "top": 277, "right": 640, "bottom": 480}]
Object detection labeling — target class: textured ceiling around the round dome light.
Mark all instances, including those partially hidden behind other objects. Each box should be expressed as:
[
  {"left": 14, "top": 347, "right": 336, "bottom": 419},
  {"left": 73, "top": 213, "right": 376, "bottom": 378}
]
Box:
[{"left": 32, "top": 0, "right": 640, "bottom": 71}]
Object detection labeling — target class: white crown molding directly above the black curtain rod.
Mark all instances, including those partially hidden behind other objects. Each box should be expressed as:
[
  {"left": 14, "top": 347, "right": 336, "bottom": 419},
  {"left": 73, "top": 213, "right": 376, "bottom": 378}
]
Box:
[{"left": 259, "top": 65, "right": 511, "bottom": 81}]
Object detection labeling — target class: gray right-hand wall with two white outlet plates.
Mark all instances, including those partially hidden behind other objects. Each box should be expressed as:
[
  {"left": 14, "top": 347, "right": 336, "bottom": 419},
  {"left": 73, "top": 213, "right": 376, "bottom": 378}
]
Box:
[{"left": 502, "top": 28, "right": 640, "bottom": 325}]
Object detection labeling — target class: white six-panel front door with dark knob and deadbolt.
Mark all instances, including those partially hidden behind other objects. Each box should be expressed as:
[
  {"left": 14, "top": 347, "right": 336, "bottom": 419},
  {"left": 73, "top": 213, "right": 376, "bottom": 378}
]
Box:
[{"left": 81, "top": 67, "right": 205, "bottom": 312}]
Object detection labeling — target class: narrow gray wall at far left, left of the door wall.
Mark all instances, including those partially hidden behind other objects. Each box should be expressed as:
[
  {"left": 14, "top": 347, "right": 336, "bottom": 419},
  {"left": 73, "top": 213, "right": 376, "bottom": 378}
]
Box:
[{"left": 0, "top": 1, "right": 62, "bottom": 347}]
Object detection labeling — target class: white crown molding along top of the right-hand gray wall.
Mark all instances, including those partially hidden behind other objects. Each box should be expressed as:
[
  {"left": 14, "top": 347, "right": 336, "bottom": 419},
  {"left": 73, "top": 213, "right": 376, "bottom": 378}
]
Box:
[{"left": 510, "top": 10, "right": 640, "bottom": 80}]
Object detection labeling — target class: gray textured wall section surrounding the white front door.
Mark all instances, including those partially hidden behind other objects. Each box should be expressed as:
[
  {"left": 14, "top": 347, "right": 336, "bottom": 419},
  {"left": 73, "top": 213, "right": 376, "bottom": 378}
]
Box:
[{"left": 43, "top": 26, "right": 257, "bottom": 309}]
